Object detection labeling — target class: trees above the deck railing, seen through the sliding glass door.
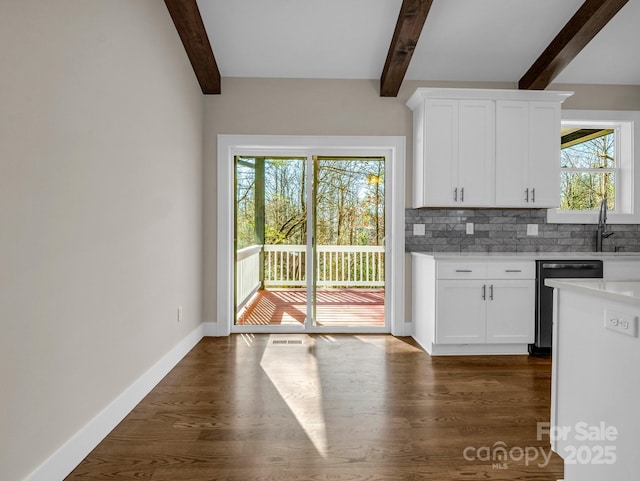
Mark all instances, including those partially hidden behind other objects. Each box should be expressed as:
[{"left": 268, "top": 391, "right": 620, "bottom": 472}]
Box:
[{"left": 236, "top": 158, "right": 385, "bottom": 248}]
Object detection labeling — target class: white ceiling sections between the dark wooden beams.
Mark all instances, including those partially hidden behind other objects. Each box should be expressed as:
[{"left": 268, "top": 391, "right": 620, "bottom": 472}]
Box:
[{"left": 198, "top": 0, "right": 640, "bottom": 85}]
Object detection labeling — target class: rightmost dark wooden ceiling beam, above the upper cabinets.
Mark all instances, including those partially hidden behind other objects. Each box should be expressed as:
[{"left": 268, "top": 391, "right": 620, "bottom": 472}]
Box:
[{"left": 518, "top": 0, "right": 629, "bottom": 90}]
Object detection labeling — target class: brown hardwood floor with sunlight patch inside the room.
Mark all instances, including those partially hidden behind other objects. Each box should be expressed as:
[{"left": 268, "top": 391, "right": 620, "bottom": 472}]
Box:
[{"left": 66, "top": 334, "right": 563, "bottom": 481}]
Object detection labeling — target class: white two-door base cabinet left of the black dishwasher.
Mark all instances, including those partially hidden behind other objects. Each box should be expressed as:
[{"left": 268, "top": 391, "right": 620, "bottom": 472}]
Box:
[{"left": 412, "top": 254, "right": 535, "bottom": 355}]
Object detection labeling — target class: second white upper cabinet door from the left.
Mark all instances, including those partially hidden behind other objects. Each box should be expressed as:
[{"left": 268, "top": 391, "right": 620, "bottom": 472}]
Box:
[{"left": 457, "top": 100, "right": 496, "bottom": 207}]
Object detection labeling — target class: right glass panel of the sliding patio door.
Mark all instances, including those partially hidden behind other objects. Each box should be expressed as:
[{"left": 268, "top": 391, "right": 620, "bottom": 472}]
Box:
[{"left": 311, "top": 157, "right": 385, "bottom": 328}]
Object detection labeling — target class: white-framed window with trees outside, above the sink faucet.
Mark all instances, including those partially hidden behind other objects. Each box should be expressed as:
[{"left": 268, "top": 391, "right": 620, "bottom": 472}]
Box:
[{"left": 547, "top": 110, "right": 640, "bottom": 224}]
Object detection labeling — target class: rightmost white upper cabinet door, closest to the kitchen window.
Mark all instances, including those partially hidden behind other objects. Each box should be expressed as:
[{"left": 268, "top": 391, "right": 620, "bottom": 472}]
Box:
[{"left": 529, "top": 102, "right": 560, "bottom": 208}]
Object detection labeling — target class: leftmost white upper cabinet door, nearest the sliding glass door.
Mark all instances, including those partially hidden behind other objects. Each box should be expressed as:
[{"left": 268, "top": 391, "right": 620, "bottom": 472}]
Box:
[{"left": 416, "top": 99, "right": 458, "bottom": 207}]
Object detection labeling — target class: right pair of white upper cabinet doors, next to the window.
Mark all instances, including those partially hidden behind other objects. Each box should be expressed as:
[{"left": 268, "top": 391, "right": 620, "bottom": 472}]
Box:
[{"left": 495, "top": 100, "right": 560, "bottom": 208}]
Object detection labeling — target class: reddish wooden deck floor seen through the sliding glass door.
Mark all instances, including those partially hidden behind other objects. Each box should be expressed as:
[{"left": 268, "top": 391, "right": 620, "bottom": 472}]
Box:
[{"left": 237, "top": 289, "right": 384, "bottom": 327}]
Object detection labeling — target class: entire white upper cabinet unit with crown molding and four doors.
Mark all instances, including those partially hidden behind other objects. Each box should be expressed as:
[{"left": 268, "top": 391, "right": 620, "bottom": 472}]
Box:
[{"left": 407, "top": 88, "right": 572, "bottom": 208}]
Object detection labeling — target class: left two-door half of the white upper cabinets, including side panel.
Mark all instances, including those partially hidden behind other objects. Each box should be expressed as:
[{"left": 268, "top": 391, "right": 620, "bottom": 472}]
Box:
[{"left": 414, "top": 99, "right": 495, "bottom": 207}]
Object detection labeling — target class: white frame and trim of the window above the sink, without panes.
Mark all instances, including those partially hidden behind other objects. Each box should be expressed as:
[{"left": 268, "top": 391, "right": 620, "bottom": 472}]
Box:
[{"left": 547, "top": 110, "right": 640, "bottom": 224}]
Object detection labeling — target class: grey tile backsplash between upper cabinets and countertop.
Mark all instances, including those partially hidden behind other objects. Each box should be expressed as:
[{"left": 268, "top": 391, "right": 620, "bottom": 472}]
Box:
[{"left": 405, "top": 209, "right": 640, "bottom": 252}]
